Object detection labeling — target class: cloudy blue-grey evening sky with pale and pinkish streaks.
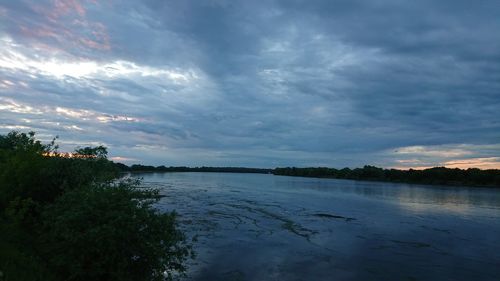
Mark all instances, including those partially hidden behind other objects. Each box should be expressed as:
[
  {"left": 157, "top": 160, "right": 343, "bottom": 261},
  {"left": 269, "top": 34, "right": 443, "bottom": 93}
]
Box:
[{"left": 0, "top": 0, "right": 500, "bottom": 169}]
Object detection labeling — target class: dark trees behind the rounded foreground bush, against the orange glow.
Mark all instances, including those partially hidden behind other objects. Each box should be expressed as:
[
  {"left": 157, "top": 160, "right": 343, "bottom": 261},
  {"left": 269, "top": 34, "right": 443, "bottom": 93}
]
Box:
[{"left": 0, "top": 132, "right": 118, "bottom": 210}]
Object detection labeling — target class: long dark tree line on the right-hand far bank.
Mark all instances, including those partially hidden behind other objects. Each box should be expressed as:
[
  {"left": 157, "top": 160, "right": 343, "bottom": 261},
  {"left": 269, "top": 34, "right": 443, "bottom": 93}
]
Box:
[{"left": 273, "top": 166, "right": 500, "bottom": 187}]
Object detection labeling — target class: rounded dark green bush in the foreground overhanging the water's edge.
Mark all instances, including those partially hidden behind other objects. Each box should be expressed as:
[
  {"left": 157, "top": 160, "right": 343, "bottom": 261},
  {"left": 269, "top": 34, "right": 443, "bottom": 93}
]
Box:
[{"left": 43, "top": 180, "right": 189, "bottom": 281}]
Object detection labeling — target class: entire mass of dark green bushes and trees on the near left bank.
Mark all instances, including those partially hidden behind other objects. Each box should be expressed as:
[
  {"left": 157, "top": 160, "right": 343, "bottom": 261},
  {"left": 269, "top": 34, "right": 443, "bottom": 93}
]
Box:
[{"left": 0, "top": 132, "right": 191, "bottom": 281}]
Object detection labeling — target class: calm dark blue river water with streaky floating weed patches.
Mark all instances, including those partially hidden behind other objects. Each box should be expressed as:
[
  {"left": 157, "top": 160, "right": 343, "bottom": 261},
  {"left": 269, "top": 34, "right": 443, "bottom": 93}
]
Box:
[{"left": 135, "top": 173, "right": 500, "bottom": 281}]
